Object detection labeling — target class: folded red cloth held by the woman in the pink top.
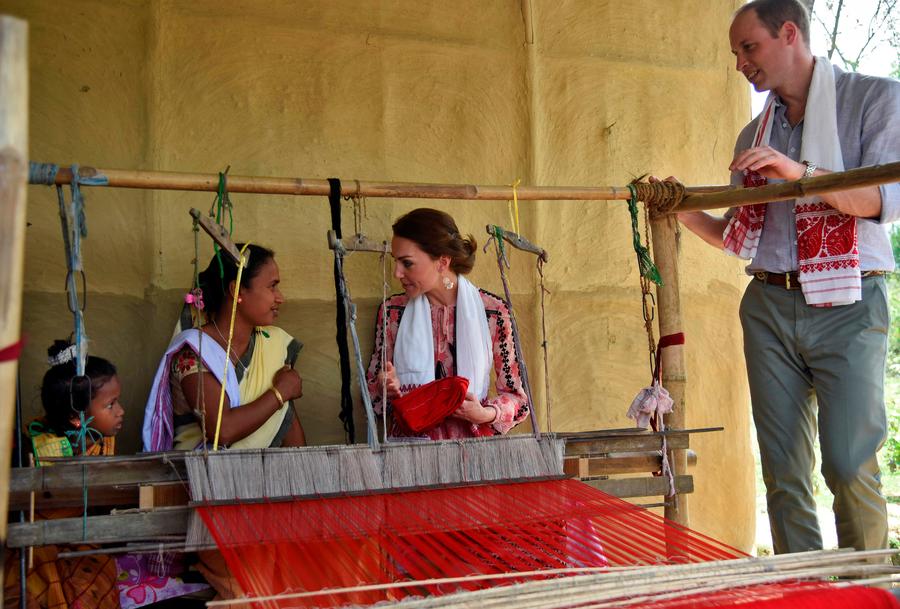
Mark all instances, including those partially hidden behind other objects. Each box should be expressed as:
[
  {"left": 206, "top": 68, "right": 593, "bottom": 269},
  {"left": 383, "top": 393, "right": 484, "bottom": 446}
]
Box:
[{"left": 391, "top": 376, "right": 469, "bottom": 434}]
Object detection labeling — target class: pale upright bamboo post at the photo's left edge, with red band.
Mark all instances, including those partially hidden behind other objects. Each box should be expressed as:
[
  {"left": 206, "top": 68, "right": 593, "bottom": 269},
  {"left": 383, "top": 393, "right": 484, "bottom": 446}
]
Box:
[{"left": 0, "top": 15, "right": 28, "bottom": 590}]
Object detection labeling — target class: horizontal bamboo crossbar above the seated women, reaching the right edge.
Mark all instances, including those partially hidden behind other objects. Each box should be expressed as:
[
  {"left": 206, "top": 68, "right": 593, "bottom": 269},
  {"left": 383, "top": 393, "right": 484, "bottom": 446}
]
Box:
[{"left": 30, "top": 162, "right": 900, "bottom": 213}]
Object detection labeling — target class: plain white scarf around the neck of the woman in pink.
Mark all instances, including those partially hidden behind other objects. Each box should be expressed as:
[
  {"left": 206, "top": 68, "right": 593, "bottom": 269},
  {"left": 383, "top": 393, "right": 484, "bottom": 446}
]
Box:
[{"left": 394, "top": 275, "right": 493, "bottom": 400}]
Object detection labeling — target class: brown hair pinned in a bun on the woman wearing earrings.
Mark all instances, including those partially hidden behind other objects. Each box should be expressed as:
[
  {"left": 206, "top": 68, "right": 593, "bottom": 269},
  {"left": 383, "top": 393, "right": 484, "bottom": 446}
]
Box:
[{"left": 393, "top": 207, "right": 478, "bottom": 275}]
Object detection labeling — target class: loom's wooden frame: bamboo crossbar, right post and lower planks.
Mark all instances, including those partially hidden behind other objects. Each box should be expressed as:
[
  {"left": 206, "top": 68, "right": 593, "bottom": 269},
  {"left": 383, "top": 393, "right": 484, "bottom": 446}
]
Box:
[{"left": 7, "top": 156, "right": 900, "bottom": 547}]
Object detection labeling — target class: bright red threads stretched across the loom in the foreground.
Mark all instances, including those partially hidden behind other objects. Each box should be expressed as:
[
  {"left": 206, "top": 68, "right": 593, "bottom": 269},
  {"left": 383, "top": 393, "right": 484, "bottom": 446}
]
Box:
[{"left": 198, "top": 480, "right": 900, "bottom": 609}]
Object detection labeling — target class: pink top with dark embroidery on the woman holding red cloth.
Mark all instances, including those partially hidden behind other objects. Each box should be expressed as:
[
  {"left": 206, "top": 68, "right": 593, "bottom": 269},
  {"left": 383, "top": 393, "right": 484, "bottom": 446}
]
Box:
[{"left": 366, "top": 289, "right": 529, "bottom": 440}]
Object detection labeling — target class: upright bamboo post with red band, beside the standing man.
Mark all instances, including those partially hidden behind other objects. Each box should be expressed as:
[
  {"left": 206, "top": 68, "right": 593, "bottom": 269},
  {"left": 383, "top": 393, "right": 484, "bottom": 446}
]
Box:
[{"left": 650, "top": 214, "right": 690, "bottom": 526}]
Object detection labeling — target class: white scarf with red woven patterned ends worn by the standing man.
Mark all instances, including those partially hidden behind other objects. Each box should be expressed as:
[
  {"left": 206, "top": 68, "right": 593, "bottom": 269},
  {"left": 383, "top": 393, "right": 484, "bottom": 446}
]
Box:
[{"left": 723, "top": 57, "right": 862, "bottom": 307}]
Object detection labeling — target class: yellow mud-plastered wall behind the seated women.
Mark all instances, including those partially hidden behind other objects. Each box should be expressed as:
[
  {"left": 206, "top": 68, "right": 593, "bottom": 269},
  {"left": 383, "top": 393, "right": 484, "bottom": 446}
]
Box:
[{"left": 0, "top": 0, "right": 754, "bottom": 549}]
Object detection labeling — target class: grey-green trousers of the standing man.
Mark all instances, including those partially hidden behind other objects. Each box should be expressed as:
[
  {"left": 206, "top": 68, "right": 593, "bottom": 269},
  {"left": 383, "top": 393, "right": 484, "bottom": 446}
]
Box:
[{"left": 741, "top": 276, "right": 890, "bottom": 553}]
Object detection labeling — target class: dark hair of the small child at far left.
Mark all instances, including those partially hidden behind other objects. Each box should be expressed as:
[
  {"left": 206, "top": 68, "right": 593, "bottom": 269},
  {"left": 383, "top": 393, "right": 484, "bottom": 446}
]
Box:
[{"left": 41, "top": 340, "right": 116, "bottom": 434}]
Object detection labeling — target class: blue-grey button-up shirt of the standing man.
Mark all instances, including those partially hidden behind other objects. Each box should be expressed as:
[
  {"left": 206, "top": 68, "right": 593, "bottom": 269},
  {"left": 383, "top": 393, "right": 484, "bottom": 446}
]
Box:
[{"left": 725, "top": 67, "right": 900, "bottom": 273}]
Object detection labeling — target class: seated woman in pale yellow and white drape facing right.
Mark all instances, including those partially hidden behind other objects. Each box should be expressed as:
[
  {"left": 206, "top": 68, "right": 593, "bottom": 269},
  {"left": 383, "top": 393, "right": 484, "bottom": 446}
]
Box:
[{"left": 143, "top": 245, "right": 306, "bottom": 451}]
